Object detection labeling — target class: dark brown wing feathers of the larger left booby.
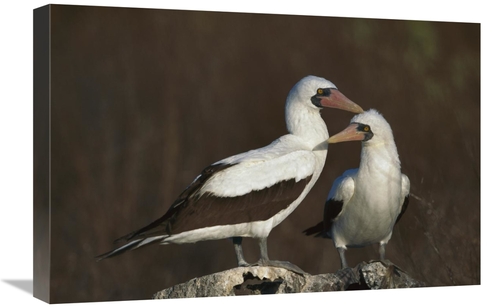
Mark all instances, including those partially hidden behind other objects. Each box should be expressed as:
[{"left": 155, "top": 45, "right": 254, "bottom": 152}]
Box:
[{"left": 115, "top": 164, "right": 311, "bottom": 241}]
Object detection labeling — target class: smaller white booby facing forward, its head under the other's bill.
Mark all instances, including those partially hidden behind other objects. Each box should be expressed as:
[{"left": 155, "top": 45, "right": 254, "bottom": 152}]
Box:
[{"left": 304, "top": 109, "right": 410, "bottom": 268}]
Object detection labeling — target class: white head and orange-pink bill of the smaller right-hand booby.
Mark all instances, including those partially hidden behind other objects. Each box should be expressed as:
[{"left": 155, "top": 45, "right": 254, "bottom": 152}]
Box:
[{"left": 327, "top": 109, "right": 394, "bottom": 145}]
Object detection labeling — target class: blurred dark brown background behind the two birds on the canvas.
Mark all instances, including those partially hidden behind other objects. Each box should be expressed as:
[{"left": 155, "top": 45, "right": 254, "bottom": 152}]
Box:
[{"left": 44, "top": 5, "right": 480, "bottom": 302}]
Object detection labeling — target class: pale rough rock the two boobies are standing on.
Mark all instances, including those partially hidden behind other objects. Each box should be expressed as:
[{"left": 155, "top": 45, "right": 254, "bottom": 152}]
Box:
[{"left": 153, "top": 261, "right": 425, "bottom": 299}]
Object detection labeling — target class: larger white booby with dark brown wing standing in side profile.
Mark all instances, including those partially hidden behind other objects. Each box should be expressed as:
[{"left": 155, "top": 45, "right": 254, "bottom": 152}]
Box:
[{"left": 96, "top": 76, "right": 363, "bottom": 268}]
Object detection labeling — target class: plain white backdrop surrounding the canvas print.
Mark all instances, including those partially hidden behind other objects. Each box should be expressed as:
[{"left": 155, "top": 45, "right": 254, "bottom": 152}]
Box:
[{"left": 0, "top": 0, "right": 494, "bottom": 307}]
